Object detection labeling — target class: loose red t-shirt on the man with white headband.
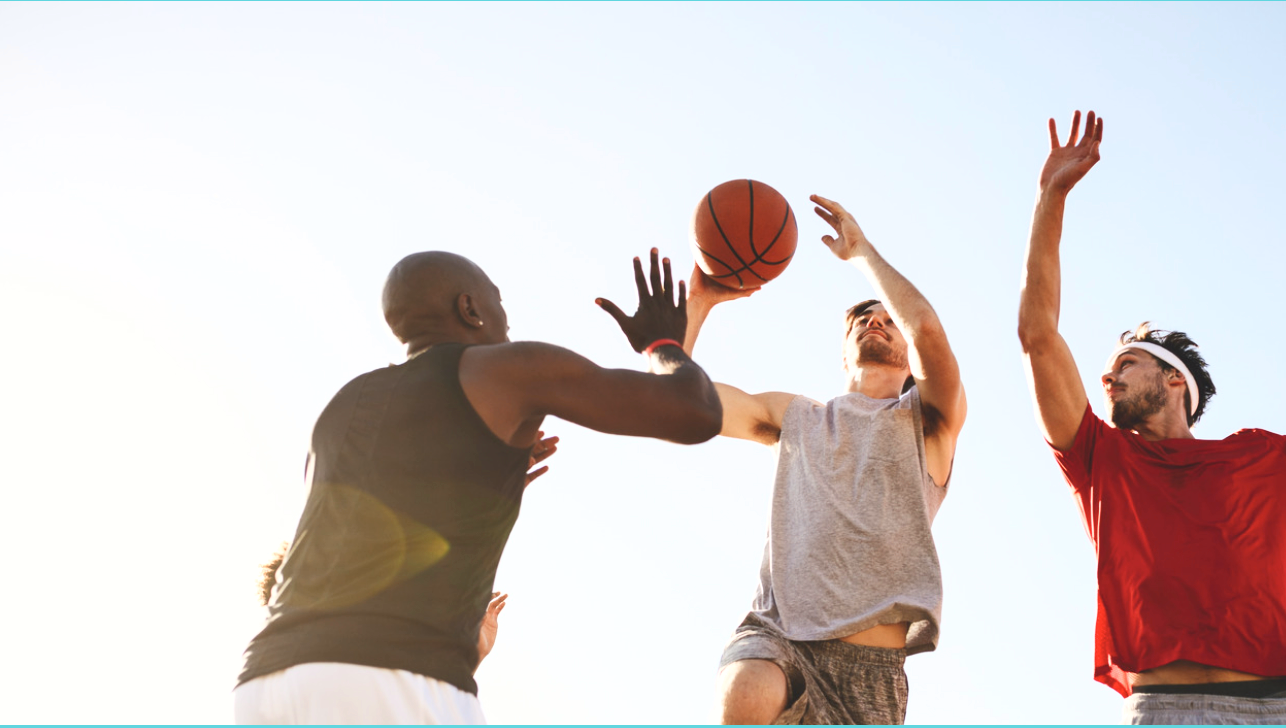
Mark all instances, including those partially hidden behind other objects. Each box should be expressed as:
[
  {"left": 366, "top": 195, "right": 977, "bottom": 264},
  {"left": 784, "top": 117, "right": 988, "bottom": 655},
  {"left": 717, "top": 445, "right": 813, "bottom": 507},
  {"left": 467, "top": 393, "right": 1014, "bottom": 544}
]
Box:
[{"left": 1055, "top": 405, "right": 1286, "bottom": 697}]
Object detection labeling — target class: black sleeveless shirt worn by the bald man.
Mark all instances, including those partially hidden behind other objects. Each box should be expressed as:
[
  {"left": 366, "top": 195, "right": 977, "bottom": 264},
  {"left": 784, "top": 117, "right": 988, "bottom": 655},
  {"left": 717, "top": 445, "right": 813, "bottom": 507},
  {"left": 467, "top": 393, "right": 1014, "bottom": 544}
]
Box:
[{"left": 238, "top": 343, "right": 530, "bottom": 693}]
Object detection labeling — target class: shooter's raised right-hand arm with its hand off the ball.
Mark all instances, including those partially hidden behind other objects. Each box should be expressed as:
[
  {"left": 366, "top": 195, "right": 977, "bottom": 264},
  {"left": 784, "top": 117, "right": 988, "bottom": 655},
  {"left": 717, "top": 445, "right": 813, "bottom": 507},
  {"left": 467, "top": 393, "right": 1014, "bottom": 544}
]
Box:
[{"left": 810, "top": 194, "right": 966, "bottom": 484}]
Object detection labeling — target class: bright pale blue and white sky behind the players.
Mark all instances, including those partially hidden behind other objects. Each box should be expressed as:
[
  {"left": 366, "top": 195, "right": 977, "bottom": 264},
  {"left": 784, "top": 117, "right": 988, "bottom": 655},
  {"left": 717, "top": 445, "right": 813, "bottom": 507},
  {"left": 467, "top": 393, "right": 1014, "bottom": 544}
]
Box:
[{"left": 0, "top": 3, "right": 1286, "bottom": 723}]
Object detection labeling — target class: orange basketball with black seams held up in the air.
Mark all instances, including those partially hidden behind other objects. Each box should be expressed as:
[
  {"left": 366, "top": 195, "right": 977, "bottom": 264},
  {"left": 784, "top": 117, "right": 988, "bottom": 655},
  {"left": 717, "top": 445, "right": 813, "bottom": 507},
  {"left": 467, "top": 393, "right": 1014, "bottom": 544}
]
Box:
[{"left": 692, "top": 180, "right": 799, "bottom": 288}]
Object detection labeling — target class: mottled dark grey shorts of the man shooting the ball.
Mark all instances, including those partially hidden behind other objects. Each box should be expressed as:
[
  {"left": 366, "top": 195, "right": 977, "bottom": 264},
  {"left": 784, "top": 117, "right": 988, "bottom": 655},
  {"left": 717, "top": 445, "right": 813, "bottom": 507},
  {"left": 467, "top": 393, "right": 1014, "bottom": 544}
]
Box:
[{"left": 719, "top": 614, "right": 907, "bottom": 725}]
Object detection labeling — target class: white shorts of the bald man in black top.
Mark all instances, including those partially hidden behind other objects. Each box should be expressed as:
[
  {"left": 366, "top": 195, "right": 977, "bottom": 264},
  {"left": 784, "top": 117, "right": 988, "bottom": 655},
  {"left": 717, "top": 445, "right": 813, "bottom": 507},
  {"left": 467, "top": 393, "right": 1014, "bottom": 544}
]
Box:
[{"left": 233, "top": 662, "right": 486, "bottom": 724}]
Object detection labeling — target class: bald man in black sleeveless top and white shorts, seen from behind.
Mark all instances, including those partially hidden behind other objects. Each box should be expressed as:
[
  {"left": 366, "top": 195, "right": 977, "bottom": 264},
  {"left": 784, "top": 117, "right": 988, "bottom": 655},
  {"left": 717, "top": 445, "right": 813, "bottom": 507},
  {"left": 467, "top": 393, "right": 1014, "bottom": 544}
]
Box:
[{"left": 234, "top": 248, "right": 723, "bottom": 723}]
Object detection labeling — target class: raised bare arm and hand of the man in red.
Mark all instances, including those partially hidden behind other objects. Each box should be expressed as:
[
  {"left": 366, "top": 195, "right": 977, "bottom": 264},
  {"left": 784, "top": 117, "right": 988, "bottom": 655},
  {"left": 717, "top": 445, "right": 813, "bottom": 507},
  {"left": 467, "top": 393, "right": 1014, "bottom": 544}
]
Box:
[{"left": 1019, "top": 111, "right": 1103, "bottom": 450}]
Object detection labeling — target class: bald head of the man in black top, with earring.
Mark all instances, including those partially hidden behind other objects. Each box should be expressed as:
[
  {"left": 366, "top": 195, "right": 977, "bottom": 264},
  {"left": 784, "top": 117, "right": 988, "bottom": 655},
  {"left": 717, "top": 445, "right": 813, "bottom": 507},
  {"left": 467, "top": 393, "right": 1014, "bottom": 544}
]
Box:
[{"left": 383, "top": 251, "right": 508, "bottom": 352}]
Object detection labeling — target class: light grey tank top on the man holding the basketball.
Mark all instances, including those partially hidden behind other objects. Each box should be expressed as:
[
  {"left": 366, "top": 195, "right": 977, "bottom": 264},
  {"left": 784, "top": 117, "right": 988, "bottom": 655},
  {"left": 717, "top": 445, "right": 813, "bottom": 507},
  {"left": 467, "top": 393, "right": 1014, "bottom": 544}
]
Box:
[{"left": 754, "top": 387, "right": 946, "bottom": 653}]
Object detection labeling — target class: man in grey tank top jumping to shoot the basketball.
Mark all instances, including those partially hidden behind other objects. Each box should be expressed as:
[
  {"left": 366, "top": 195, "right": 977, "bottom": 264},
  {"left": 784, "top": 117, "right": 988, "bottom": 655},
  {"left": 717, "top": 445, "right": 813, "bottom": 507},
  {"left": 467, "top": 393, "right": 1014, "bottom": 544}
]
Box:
[{"left": 684, "top": 196, "right": 966, "bottom": 724}]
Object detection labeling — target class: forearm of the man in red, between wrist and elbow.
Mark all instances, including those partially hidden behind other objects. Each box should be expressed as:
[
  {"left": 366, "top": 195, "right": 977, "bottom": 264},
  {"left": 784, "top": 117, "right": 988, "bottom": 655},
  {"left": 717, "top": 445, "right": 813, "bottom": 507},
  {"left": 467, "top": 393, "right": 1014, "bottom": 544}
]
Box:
[{"left": 1019, "top": 190, "right": 1067, "bottom": 351}]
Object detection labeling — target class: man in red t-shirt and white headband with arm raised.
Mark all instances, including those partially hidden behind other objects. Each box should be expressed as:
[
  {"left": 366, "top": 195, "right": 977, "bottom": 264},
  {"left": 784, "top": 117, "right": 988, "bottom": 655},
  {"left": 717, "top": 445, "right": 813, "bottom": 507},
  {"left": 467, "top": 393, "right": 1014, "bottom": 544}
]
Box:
[{"left": 1019, "top": 112, "right": 1286, "bottom": 724}]
